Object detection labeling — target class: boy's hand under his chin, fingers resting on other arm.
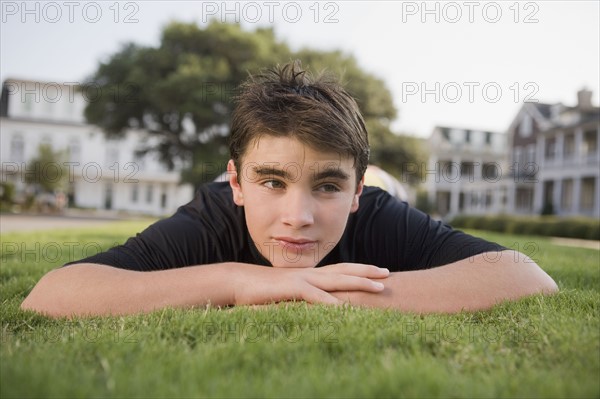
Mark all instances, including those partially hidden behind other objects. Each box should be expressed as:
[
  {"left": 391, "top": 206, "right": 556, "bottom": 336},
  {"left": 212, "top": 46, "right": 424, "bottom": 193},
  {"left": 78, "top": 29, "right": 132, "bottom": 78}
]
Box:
[{"left": 232, "top": 263, "right": 389, "bottom": 305}]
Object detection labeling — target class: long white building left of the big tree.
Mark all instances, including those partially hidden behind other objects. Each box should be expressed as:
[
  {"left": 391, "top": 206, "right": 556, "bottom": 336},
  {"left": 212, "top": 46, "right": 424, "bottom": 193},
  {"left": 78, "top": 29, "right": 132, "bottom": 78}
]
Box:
[{"left": 0, "top": 79, "right": 193, "bottom": 216}]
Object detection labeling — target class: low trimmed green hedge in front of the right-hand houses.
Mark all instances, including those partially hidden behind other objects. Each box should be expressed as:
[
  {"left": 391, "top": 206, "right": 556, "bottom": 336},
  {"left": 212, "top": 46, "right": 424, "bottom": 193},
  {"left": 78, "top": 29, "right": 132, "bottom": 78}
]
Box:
[{"left": 450, "top": 215, "right": 600, "bottom": 240}]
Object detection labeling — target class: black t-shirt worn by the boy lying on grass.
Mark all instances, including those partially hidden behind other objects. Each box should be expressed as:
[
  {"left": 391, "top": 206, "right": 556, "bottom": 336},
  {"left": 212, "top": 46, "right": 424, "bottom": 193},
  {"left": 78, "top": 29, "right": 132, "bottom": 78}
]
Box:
[{"left": 69, "top": 183, "right": 505, "bottom": 271}]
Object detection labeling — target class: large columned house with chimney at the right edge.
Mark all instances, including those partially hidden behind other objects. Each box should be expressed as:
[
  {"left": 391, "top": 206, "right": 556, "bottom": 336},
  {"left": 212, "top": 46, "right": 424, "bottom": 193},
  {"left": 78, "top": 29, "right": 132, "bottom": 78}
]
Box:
[{"left": 507, "top": 90, "right": 600, "bottom": 218}]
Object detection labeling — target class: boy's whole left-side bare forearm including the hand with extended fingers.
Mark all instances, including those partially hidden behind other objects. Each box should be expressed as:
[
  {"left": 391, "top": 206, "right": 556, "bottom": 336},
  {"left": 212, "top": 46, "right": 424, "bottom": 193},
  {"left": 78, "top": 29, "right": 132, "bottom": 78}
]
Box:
[{"left": 21, "top": 263, "right": 389, "bottom": 317}]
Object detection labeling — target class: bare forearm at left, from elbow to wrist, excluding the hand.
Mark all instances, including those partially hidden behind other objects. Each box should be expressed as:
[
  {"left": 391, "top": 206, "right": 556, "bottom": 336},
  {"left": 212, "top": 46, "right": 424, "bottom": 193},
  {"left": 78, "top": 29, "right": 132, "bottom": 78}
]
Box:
[{"left": 21, "top": 264, "right": 241, "bottom": 317}]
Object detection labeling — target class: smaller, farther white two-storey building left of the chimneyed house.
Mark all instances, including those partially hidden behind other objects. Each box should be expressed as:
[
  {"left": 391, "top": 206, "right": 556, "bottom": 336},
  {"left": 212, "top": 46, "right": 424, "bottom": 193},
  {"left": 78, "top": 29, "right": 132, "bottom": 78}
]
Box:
[{"left": 426, "top": 126, "right": 510, "bottom": 218}]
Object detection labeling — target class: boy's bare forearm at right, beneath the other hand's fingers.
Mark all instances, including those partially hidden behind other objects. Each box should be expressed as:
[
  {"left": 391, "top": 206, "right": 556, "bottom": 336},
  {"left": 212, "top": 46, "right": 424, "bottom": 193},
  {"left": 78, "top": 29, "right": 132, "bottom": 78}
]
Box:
[{"left": 334, "top": 251, "right": 558, "bottom": 313}]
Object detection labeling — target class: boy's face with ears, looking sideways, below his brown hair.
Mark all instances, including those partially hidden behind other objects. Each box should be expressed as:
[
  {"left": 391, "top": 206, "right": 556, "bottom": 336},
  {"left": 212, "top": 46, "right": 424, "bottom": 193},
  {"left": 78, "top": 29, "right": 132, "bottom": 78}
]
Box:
[{"left": 228, "top": 135, "right": 362, "bottom": 267}]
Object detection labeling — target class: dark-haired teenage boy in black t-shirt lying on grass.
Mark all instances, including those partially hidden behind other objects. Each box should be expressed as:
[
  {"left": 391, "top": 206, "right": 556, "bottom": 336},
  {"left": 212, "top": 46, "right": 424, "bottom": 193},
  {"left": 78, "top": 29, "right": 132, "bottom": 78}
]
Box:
[{"left": 22, "top": 63, "right": 557, "bottom": 317}]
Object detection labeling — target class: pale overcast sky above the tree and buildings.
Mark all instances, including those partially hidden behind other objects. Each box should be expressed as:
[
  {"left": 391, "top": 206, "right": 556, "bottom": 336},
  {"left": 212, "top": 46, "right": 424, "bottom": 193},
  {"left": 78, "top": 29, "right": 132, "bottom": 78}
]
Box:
[{"left": 0, "top": 0, "right": 600, "bottom": 137}]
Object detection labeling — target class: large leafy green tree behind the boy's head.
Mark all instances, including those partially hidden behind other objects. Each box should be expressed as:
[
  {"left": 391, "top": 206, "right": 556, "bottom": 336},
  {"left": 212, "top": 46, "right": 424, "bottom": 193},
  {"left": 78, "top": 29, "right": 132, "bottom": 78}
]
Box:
[{"left": 82, "top": 21, "right": 422, "bottom": 185}]
